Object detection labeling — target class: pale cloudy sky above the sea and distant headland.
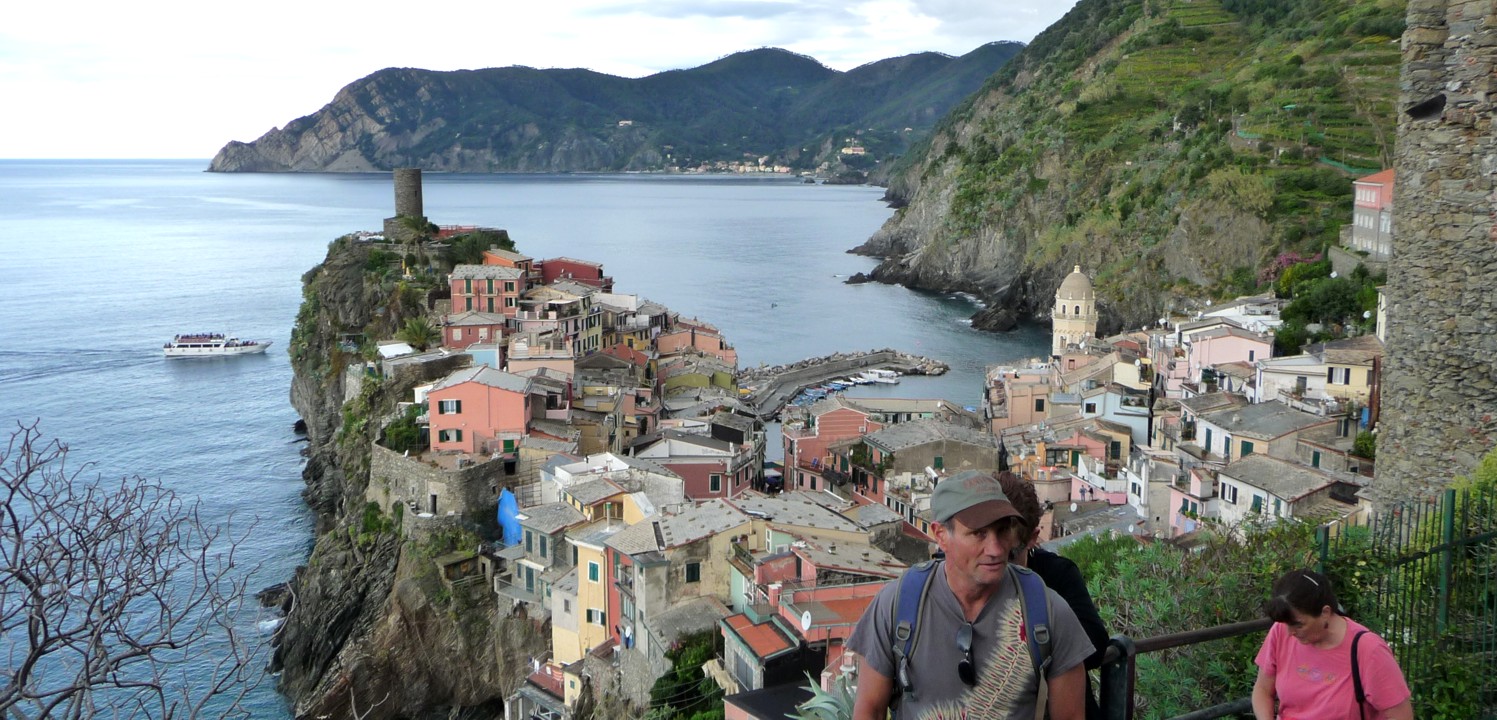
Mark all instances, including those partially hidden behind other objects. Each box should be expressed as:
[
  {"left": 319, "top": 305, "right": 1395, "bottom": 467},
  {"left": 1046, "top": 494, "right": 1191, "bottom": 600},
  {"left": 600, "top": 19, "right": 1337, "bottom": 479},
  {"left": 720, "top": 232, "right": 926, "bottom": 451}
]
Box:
[{"left": 0, "top": 0, "right": 1075, "bottom": 160}]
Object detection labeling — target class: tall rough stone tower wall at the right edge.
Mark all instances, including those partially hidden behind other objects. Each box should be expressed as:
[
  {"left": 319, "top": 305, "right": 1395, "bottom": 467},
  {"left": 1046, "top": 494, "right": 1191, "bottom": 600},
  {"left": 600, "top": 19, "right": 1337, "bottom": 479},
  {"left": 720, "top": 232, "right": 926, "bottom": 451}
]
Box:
[{"left": 1373, "top": 0, "right": 1497, "bottom": 501}]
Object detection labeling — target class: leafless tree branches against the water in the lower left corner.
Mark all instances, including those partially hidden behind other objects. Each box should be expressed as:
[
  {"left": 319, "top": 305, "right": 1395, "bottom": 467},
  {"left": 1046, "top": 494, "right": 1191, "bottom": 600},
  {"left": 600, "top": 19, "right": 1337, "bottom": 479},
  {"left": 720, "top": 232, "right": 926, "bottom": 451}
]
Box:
[{"left": 0, "top": 424, "right": 260, "bottom": 720}]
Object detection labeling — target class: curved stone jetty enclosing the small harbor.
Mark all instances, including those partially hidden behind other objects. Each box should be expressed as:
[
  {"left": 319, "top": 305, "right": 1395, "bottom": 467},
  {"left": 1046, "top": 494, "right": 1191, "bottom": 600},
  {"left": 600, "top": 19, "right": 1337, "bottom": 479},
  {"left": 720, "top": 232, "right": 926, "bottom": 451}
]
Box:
[{"left": 738, "top": 347, "right": 951, "bottom": 419}]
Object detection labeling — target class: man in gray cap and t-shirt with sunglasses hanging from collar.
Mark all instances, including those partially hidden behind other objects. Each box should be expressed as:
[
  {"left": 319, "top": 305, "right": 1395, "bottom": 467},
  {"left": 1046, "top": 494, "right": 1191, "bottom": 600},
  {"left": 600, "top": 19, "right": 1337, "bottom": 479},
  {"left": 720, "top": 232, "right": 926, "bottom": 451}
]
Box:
[{"left": 847, "top": 470, "right": 1094, "bottom": 720}]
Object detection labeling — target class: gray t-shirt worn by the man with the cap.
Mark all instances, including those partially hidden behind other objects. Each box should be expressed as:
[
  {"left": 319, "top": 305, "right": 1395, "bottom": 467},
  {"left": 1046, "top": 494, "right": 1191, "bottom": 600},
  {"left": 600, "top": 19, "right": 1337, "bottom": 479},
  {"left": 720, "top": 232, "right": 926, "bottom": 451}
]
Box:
[{"left": 847, "top": 563, "right": 1096, "bottom": 720}]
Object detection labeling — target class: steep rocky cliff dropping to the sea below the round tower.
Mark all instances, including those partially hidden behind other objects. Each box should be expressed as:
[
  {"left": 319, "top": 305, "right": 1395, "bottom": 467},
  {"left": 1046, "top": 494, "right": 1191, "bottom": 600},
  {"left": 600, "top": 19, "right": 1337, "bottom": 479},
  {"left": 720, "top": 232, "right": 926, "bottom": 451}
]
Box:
[{"left": 272, "top": 238, "right": 546, "bottom": 719}]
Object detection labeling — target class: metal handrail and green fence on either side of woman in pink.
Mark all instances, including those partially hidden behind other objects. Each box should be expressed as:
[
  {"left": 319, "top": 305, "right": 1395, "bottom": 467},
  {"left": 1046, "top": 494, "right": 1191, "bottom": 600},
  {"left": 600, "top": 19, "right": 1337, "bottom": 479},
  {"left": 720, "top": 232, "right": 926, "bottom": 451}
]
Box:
[{"left": 1100, "top": 489, "right": 1497, "bottom": 720}]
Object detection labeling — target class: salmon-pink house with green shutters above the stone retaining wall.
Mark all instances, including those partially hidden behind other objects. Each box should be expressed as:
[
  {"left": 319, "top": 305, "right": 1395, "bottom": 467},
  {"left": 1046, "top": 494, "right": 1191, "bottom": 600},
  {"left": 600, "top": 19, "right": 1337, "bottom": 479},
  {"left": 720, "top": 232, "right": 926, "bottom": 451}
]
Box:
[{"left": 427, "top": 365, "right": 531, "bottom": 454}]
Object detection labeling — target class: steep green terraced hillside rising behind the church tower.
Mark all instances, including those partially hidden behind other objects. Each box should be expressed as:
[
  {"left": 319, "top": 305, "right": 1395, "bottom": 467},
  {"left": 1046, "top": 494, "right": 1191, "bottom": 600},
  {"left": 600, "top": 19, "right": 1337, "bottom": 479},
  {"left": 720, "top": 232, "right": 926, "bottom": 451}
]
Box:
[{"left": 859, "top": 0, "right": 1404, "bottom": 328}]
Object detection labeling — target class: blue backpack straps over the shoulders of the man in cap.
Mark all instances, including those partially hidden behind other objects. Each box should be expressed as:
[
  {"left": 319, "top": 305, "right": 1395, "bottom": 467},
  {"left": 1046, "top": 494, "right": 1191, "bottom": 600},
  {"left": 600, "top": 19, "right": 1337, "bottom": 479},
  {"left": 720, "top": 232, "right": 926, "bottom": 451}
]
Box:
[{"left": 889, "top": 560, "right": 1051, "bottom": 706}]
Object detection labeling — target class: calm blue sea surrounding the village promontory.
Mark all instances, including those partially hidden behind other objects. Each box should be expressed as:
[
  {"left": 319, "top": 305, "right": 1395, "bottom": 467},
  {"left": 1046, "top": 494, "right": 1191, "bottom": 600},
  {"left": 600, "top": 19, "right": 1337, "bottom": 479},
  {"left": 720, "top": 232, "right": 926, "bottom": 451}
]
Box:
[{"left": 0, "top": 160, "right": 1049, "bottom": 717}]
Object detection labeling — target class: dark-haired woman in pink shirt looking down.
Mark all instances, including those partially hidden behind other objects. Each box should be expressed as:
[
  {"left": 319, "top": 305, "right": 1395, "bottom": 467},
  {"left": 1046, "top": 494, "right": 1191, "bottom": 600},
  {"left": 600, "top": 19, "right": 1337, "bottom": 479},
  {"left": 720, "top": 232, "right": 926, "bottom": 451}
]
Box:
[{"left": 1253, "top": 570, "right": 1413, "bottom": 720}]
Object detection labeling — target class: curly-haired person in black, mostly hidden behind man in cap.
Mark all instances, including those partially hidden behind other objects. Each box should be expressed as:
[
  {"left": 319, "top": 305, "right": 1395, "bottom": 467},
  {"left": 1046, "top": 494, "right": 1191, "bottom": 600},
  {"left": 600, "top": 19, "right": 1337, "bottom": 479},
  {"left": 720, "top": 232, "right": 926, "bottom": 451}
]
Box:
[{"left": 997, "top": 472, "right": 1109, "bottom": 720}]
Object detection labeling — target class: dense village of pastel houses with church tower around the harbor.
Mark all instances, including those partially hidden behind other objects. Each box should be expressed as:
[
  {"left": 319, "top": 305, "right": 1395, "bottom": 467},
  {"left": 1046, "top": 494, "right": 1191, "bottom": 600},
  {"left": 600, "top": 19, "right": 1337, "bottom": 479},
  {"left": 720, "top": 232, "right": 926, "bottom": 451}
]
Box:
[{"left": 324, "top": 163, "right": 1392, "bottom": 719}]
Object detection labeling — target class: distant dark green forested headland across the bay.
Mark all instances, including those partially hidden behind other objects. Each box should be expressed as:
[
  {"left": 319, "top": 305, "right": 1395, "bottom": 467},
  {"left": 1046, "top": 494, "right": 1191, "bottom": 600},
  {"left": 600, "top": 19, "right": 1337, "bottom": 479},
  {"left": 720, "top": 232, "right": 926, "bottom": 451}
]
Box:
[{"left": 211, "top": 42, "right": 1022, "bottom": 172}]
